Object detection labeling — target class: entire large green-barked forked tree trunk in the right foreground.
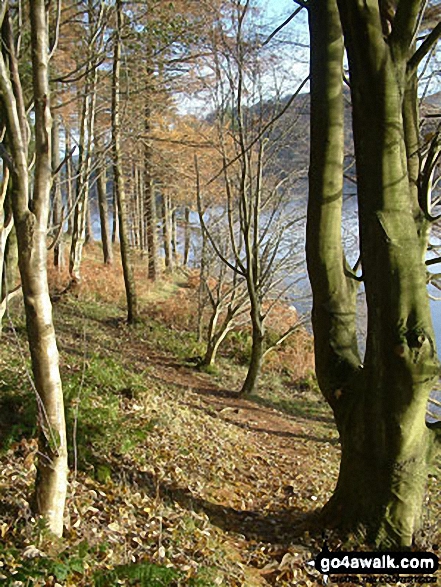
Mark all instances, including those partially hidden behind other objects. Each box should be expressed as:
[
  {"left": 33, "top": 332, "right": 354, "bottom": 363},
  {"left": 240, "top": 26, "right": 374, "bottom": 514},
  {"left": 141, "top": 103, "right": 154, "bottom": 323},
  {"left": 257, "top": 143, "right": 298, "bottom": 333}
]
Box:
[{"left": 307, "top": 0, "right": 438, "bottom": 547}]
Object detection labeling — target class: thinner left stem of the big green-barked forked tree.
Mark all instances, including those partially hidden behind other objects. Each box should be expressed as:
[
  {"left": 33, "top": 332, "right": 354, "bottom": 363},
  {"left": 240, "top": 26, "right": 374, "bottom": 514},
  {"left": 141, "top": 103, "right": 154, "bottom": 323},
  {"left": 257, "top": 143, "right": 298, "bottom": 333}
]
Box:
[{"left": 306, "top": 0, "right": 361, "bottom": 418}]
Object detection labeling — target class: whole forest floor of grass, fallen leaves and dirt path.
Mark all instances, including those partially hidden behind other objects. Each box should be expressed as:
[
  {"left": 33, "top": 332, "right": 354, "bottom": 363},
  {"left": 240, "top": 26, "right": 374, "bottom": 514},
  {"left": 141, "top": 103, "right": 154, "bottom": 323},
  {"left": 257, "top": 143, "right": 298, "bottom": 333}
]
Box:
[{"left": 0, "top": 246, "right": 441, "bottom": 587}]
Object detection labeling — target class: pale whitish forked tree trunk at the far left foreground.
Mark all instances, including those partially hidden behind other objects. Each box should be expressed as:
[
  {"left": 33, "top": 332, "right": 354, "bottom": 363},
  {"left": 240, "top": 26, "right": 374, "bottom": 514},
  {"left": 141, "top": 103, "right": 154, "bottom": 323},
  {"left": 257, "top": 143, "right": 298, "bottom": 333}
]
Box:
[{"left": 0, "top": 0, "right": 67, "bottom": 536}]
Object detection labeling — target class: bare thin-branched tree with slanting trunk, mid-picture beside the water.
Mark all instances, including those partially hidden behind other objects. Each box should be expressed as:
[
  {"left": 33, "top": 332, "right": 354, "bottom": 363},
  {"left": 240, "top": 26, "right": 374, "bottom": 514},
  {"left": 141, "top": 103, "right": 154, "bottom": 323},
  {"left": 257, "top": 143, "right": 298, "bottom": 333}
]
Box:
[{"left": 198, "top": 2, "right": 306, "bottom": 395}]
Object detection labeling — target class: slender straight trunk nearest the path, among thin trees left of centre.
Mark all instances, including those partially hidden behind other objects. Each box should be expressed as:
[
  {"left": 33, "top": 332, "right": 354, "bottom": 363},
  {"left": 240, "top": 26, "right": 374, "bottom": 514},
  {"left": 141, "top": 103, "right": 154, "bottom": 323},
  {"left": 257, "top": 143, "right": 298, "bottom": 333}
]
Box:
[{"left": 112, "top": 0, "right": 138, "bottom": 324}]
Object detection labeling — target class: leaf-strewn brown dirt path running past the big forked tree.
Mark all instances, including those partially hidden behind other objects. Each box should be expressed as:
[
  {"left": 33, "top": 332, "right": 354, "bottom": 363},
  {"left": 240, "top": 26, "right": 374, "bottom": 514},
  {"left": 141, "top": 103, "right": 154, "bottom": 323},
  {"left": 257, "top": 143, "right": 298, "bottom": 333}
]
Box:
[{"left": 51, "top": 304, "right": 338, "bottom": 586}]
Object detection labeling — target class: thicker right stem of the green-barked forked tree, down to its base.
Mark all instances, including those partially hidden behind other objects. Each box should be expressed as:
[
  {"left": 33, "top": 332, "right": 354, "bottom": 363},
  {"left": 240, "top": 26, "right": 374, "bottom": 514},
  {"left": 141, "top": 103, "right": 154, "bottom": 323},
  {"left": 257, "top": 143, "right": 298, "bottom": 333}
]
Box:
[{"left": 339, "top": 2, "right": 438, "bottom": 546}]
